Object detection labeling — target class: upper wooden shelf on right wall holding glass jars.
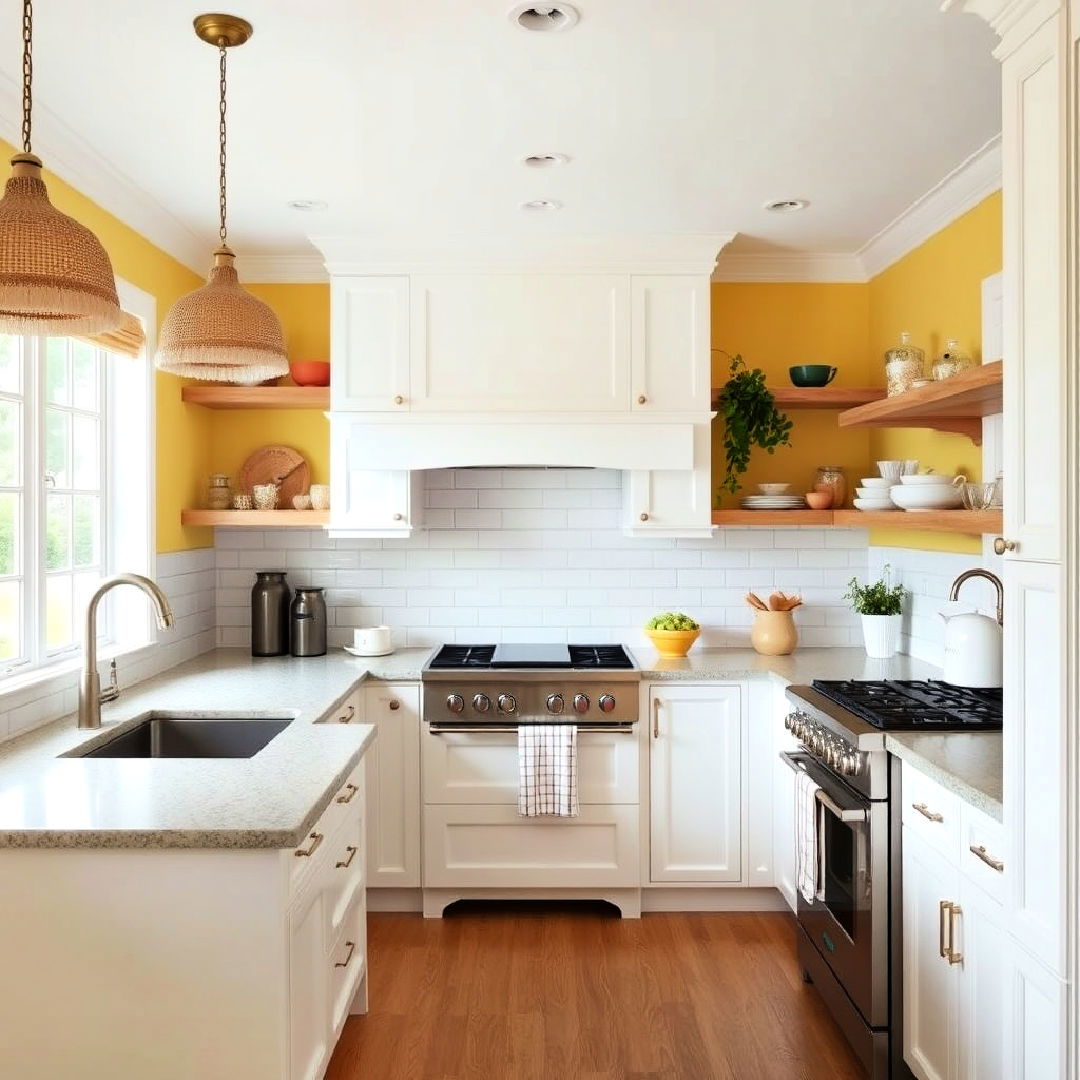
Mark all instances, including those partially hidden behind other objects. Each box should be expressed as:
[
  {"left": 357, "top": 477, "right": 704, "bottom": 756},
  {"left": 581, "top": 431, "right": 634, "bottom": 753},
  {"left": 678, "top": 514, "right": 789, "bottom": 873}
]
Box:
[{"left": 837, "top": 360, "right": 1001, "bottom": 444}]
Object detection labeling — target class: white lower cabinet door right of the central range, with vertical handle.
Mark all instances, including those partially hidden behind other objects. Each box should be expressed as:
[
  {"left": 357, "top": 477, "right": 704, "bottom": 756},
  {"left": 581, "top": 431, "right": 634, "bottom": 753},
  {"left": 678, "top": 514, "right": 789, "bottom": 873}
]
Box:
[{"left": 648, "top": 683, "right": 743, "bottom": 883}]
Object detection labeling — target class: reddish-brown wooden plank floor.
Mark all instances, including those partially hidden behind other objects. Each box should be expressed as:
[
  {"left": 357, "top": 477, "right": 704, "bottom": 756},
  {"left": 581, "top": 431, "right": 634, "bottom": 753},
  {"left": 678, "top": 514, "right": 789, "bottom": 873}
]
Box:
[{"left": 326, "top": 905, "right": 863, "bottom": 1080}]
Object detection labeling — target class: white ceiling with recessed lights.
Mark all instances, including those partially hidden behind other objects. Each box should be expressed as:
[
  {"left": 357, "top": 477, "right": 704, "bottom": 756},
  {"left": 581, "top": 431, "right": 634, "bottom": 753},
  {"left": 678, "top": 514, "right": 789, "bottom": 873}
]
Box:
[{"left": 0, "top": 0, "right": 1000, "bottom": 269}]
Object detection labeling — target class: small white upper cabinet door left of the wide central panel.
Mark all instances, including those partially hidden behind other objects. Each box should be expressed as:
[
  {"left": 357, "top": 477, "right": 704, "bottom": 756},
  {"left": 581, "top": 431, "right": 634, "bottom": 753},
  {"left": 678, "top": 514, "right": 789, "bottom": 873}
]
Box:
[{"left": 330, "top": 276, "right": 409, "bottom": 413}]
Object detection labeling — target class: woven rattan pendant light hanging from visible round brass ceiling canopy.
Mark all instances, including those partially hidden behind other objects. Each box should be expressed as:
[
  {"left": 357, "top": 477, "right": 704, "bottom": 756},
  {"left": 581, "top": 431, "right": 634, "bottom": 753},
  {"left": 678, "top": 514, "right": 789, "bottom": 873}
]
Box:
[{"left": 156, "top": 15, "right": 288, "bottom": 383}]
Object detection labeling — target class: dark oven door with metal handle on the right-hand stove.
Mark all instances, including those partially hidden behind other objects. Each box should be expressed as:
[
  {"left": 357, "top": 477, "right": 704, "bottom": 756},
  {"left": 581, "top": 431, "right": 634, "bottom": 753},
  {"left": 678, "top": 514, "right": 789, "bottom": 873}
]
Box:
[{"left": 781, "top": 752, "right": 889, "bottom": 1027}]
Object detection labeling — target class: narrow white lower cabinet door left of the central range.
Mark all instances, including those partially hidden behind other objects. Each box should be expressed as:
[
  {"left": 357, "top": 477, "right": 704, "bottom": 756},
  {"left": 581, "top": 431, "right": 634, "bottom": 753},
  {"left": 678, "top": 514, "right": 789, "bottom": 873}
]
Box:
[{"left": 364, "top": 684, "right": 420, "bottom": 889}]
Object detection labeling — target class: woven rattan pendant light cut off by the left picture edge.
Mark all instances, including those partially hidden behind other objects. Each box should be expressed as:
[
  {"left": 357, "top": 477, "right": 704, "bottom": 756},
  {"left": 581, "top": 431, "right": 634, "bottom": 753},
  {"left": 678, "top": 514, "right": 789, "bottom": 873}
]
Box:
[{"left": 0, "top": 0, "right": 123, "bottom": 337}]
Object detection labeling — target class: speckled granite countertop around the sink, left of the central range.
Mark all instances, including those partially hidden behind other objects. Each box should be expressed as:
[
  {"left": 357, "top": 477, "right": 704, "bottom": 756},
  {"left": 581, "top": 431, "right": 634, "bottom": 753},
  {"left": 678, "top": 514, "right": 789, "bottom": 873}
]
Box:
[{"left": 0, "top": 649, "right": 430, "bottom": 848}]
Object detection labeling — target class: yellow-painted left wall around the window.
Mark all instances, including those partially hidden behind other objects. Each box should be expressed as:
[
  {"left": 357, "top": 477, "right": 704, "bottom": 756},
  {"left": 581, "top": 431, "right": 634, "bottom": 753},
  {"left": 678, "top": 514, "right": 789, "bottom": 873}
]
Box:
[{"left": 0, "top": 140, "right": 213, "bottom": 552}]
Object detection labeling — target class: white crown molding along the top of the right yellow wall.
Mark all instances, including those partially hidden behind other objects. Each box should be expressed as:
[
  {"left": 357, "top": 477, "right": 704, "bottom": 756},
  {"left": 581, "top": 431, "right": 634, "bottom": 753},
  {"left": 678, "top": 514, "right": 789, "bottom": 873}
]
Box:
[{"left": 855, "top": 135, "right": 1001, "bottom": 280}]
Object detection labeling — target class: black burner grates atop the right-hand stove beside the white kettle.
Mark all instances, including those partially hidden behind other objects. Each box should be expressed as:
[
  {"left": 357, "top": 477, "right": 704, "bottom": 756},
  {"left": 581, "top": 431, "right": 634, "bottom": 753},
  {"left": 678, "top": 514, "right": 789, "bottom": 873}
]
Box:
[{"left": 812, "top": 679, "right": 1002, "bottom": 731}]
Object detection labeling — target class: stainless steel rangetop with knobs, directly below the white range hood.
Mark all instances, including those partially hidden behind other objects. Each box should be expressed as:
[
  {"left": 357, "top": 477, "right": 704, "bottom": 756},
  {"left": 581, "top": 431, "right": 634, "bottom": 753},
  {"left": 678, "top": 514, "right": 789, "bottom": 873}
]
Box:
[{"left": 420, "top": 643, "right": 640, "bottom": 730}]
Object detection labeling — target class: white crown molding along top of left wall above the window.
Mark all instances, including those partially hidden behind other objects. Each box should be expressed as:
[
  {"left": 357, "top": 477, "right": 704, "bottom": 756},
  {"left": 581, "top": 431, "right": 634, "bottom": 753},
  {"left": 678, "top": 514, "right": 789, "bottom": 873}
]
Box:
[{"left": 0, "top": 72, "right": 211, "bottom": 274}]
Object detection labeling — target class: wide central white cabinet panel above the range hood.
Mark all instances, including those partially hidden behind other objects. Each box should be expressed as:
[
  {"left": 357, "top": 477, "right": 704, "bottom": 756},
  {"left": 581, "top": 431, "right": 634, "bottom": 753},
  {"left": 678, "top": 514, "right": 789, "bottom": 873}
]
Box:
[{"left": 409, "top": 273, "right": 631, "bottom": 416}]
